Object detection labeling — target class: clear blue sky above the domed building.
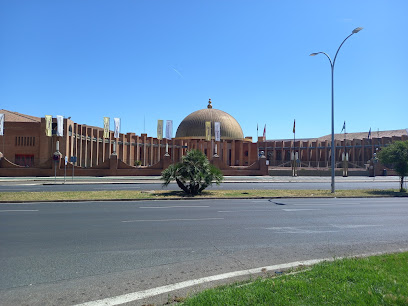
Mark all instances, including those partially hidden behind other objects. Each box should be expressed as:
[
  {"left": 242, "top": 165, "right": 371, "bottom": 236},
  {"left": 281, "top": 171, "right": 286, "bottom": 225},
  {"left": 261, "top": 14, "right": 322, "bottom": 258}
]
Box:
[{"left": 0, "top": 0, "right": 408, "bottom": 139}]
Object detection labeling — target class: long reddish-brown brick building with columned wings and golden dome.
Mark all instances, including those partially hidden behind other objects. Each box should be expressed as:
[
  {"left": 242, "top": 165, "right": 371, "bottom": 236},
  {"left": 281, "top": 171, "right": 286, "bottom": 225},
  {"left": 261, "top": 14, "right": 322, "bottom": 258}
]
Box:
[{"left": 0, "top": 104, "right": 408, "bottom": 176}]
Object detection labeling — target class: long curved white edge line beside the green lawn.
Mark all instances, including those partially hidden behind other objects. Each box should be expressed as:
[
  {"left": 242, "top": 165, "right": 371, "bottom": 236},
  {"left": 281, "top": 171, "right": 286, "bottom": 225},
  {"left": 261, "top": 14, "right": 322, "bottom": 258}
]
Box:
[{"left": 76, "top": 258, "right": 328, "bottom": 306}]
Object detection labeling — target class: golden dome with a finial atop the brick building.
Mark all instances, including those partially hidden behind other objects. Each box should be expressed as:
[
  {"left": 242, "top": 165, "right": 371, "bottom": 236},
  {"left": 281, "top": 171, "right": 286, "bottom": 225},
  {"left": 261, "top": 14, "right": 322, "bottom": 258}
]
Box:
[{"left": 175, "top": 99, "right": 244, "bottom": 140}]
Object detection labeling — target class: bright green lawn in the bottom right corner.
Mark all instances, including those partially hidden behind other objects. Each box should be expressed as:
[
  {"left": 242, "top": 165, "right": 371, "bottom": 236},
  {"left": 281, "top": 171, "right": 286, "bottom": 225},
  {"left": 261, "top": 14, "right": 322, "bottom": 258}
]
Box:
[{"left": 183, "top": 252, "right": 408, "bottom": 305}]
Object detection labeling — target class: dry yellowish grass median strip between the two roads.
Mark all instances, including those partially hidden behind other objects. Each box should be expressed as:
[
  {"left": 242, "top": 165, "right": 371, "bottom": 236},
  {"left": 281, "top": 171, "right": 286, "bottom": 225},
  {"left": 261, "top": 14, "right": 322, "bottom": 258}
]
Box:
[{"left": 0, "top": 189, "right": 408, "bottom": 202}]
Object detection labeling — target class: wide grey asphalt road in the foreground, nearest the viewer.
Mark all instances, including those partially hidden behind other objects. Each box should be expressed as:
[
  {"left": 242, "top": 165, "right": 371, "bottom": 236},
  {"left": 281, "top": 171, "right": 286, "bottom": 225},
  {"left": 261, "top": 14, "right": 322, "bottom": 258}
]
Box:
[{"left": 0, "top": 198, "right": 408, "bottom": 305}]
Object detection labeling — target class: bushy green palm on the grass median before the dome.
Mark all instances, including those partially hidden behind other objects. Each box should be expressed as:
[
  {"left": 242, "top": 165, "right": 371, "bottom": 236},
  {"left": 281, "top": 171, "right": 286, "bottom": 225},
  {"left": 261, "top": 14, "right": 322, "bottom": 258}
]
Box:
[{"left": 161, "top": 150, "right": 224, "bottom": 196}]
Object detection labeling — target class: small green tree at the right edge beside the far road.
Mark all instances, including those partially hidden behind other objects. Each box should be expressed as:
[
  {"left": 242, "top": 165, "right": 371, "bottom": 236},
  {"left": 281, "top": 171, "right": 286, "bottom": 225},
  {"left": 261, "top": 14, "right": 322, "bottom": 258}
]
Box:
[{"left": 379, "top": 140, "right": 408, "bottom": 192}]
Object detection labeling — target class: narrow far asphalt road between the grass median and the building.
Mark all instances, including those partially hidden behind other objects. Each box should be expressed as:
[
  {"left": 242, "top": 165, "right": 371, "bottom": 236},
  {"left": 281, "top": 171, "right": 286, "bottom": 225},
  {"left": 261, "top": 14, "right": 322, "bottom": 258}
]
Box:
[{"left": 0, "top": 180, "right": 399, "bottom": 192}]
